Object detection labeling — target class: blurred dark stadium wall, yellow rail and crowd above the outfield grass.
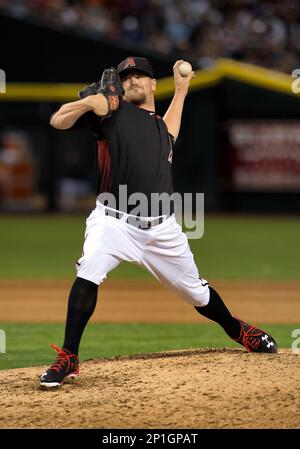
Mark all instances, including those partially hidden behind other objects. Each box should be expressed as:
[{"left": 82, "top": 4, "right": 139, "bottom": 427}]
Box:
[{"left": 0, "top": 0, "right": 300, "bottom": 212}]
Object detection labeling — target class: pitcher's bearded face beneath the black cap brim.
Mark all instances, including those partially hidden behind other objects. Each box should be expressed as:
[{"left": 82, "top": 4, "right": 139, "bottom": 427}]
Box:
[{"left": 122, "top": 72, "right": 154, "bottom": 106}]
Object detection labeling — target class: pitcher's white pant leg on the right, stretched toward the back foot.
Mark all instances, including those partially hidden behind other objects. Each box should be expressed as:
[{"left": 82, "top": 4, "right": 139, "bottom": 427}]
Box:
[{"left": 142, "top": 216, "right": 209, "bottom": 306}]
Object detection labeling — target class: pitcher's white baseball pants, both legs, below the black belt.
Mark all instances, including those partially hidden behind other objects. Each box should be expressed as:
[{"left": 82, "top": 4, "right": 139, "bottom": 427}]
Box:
[{"left": 76, "top": 201, "right": 209, "bottom": 306}]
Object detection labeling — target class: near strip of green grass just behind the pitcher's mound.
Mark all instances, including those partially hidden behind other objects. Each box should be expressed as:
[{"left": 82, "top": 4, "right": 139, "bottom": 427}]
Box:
[{"left": 0, "top": 323, "right": 300, "bottom": 369}]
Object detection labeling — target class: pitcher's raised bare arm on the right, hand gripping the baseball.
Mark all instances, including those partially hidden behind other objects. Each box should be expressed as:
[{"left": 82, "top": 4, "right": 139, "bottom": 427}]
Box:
[{"left": 163, "top": 60, "right": 194, "bottom": 140}]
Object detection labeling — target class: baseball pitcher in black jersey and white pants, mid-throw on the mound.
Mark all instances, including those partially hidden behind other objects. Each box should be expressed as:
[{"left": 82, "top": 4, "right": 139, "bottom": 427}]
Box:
[{"left": 40, "top": 57, "right": 277, "bottom": 388}]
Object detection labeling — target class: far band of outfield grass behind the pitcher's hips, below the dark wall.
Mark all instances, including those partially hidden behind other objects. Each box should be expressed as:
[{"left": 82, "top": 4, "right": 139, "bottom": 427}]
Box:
[{"left": 0, "top": 215, "right": 300, "bottom": 279}]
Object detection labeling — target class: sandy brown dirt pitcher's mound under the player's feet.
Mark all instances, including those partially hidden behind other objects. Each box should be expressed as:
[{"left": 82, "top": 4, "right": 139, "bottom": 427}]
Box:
[{"left": 0, "top": 348, "right": 300, "bottom": 429}]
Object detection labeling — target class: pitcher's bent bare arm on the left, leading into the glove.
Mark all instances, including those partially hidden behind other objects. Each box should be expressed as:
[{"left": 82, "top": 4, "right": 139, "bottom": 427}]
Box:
[{"left": 50, "top": 93, "right": 108, "bottom": 129}]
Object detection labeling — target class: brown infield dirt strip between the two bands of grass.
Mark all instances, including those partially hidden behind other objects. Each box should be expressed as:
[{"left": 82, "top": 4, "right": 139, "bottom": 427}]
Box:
[{"left": 0, "top": 279, "right": 300, "bottom": 325}]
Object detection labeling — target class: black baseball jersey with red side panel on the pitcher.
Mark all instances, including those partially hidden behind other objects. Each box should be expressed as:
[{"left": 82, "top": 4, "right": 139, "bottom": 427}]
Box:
[{"left": 74, "top": 100, "right": 174, "bottom": 215}]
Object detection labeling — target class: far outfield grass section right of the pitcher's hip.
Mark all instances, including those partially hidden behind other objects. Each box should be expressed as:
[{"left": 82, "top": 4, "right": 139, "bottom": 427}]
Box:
[{"left": 190, "top": 216, "right": 300, "bottom": 279}]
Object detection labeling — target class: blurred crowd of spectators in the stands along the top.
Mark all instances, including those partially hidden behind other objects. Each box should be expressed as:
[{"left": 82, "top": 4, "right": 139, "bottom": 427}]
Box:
[{"left": 0, "top": 0, "right": 300, "bottom": 73}]
